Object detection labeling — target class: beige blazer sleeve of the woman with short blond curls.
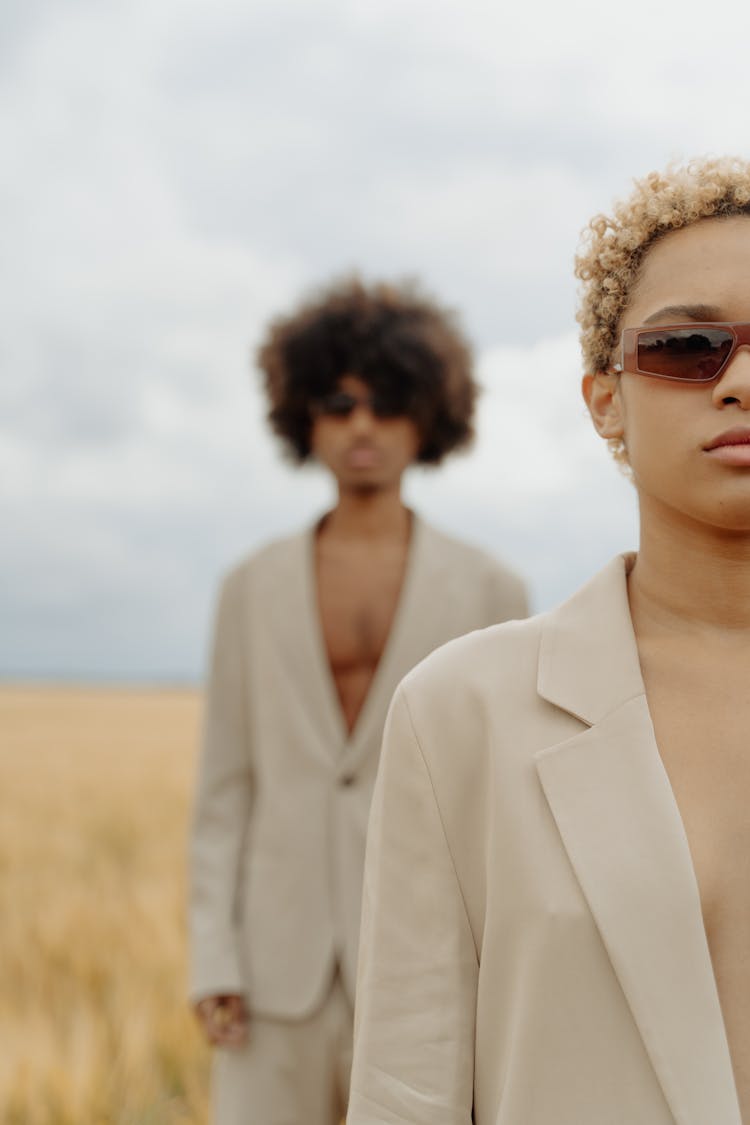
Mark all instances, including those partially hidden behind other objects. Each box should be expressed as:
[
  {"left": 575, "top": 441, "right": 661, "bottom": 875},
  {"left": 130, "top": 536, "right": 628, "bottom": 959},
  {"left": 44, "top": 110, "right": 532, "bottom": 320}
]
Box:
[{"left": 346, "top": 686, "right": 478, "bottom": 1125}]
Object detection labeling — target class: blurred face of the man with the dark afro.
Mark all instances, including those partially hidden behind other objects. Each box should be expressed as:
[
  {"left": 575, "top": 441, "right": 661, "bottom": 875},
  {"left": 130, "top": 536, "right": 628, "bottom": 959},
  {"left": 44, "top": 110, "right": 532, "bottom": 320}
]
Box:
[{"left": 311, "top": 375, "right": 419, "bottom": 492}]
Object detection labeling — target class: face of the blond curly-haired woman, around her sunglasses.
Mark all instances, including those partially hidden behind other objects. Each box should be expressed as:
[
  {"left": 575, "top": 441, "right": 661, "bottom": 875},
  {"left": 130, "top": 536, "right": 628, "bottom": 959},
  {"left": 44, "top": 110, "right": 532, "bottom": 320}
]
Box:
[{"left": 584, "top": 216, "right": 750, "bottom": 531}]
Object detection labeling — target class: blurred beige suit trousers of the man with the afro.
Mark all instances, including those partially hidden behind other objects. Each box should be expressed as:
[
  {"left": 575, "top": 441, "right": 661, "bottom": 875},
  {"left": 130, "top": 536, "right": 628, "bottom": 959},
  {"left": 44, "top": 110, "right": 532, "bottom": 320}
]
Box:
[{"left": 213, "top": 971, "right": 353, "bottom": 1125}]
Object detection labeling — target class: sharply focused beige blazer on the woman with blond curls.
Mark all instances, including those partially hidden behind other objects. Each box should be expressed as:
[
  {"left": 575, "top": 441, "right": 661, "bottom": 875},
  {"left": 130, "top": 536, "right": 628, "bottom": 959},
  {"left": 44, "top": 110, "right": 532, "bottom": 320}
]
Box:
[{"left": 347, "top": 558, "right": 740, "bottom": 1125}]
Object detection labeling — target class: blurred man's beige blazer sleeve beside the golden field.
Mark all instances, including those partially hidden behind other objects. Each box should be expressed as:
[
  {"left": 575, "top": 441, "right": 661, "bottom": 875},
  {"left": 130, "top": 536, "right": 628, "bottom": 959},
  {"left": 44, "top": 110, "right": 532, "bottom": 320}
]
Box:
[{"left": 189, "top": 572, "right": 252, "bottom": 1000}]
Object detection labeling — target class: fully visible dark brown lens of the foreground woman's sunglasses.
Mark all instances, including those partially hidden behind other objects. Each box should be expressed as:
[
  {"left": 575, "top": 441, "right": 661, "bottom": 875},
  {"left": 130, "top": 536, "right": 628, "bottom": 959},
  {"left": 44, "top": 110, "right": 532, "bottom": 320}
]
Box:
[{"left": 638, "top": 329, "right": 734, "bottom": 383}]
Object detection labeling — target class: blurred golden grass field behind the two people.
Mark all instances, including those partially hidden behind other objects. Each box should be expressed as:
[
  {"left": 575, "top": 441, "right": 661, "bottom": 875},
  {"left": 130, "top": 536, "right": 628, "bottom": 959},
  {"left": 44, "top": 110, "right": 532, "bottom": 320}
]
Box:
[{"left": 0, "top": 686, "right": 208, "bottom": 1125}]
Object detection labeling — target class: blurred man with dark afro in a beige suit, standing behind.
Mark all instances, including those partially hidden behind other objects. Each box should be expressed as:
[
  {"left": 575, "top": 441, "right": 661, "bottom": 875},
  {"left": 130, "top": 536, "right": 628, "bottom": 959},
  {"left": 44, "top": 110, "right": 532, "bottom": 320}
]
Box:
[{"left": 191, "top": 280, "right": 526, "bottom": 1125}]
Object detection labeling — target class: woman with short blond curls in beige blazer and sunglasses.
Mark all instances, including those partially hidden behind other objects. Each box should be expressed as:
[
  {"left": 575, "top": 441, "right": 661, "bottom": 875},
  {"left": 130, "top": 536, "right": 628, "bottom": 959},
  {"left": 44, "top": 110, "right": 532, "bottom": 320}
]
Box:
[{"left": 347, "top": 160, "right": 750, "bottom": 1125}]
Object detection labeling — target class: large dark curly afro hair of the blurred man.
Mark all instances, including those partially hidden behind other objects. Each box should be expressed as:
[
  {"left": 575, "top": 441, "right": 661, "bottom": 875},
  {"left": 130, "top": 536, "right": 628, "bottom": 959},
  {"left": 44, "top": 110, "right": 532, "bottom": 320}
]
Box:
[{"left": 257, "top": 276, "right": 479, "bottom": 465}]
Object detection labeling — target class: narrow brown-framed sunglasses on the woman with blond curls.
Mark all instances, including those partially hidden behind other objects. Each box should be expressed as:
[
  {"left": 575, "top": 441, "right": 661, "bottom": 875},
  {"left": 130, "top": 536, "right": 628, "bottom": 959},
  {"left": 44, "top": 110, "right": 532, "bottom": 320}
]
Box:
[{"left": 613, "top": 322, "right": 750, "bottom": 383}]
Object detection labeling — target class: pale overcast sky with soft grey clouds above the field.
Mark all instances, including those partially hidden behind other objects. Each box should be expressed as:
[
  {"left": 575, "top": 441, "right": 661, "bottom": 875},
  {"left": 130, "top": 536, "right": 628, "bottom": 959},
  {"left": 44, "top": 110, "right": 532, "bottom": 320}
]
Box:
[{"left": 0, "top": 0, "right": 750, "bottom": 678}]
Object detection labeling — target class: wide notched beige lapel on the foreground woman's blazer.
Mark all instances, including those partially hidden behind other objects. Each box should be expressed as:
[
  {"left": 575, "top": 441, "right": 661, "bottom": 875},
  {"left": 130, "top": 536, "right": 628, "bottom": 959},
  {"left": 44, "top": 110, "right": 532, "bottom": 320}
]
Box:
[{"left": 536, "top": 559, "right": 741, "bottom": 1125}]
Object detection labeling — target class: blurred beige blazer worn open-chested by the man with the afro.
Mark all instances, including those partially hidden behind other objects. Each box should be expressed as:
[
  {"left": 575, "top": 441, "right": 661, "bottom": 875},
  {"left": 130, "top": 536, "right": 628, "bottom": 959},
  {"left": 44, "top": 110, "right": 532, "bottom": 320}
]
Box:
[{"left": 190, "top": 519, "right": 526, "bottom": 1017}]
